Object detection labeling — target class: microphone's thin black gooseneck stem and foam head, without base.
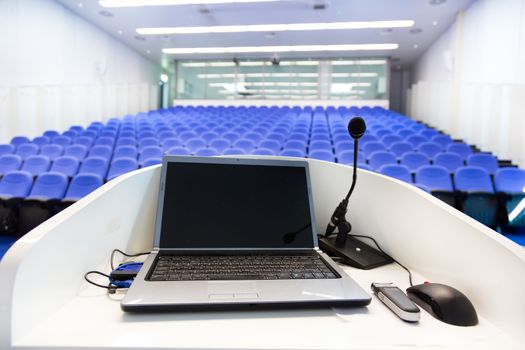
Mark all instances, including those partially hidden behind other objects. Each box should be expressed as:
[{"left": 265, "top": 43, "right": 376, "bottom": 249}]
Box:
[{"left": 325, "top": 117, "right": 366, "bottom": 243}]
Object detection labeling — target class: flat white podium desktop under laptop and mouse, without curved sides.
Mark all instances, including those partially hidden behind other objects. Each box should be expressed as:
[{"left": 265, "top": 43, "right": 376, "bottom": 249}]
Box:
[{"left": 13, "top": 264, "right": 525, "bottom": 349}]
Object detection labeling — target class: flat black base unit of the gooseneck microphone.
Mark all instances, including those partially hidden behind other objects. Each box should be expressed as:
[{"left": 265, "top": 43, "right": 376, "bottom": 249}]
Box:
[{"left": 319, "top": 236, "right": 394, "bottom": 270}]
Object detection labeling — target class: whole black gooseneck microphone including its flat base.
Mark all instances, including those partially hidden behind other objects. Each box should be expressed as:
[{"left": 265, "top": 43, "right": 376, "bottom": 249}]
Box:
[{"left": 319, "top": 117, "right": 393, "bottom": 270}]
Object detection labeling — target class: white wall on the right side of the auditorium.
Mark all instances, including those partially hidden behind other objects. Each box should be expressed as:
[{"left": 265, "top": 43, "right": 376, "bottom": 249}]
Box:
[{"left": 407, "top": 0, "right": 525, "bottom": 167}]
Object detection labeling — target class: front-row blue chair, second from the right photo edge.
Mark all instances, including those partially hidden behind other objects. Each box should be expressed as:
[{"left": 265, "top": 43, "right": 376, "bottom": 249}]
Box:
[{"left": 454, "top": 166, "right": 499, "bottom": 229}]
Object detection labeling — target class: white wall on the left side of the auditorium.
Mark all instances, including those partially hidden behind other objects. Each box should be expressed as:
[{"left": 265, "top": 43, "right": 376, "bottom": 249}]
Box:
[{"left": 0, "top": 0, "right": 161, "bottom": 143}]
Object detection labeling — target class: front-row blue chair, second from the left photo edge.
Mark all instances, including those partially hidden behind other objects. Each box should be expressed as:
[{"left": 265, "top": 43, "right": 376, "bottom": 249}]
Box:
[{"left": 18, "top": 172, "right": 68, "bottom": 234}]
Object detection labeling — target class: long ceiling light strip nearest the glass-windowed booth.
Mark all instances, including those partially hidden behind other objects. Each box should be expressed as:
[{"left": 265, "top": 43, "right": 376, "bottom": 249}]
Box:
[{"left": 162, "top": 44, "right": 399, "bottom": 55}]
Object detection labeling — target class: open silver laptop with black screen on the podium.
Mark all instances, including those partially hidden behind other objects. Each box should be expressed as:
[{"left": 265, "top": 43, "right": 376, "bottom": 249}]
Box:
[{"left": 121, "top": 156, "right": 370, "bottom": 311}]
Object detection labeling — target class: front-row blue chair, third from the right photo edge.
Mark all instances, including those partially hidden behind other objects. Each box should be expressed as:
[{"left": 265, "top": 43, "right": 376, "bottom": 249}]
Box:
[{"left": 414, "top": 165, "right": 457, "bottom": 207}]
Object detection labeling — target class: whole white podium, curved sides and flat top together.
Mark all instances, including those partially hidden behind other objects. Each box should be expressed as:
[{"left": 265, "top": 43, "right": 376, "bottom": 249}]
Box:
[{"left": 0, "top": 160, "right": 525, "bottom": 349}]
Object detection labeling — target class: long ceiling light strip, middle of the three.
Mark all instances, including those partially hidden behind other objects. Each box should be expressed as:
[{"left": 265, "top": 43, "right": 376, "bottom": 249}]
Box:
[{"left": 137, "top": 20, "right": 414, "bottom": 35}]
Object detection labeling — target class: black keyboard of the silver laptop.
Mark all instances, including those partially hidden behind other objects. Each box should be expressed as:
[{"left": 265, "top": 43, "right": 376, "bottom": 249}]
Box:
[{"left": 149, "top": 255, "right": 339, "bottom": 281}]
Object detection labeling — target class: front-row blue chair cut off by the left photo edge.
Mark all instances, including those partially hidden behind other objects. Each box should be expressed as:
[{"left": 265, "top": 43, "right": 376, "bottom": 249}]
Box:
[{"left": 0, "top": 170, "right": 33, "bottom": 235}]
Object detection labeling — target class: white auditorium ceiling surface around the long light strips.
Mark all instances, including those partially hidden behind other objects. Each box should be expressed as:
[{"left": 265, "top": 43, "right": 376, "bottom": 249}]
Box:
[{"left": 57, "top": 0, "right": 475, "bottom": 68}]
